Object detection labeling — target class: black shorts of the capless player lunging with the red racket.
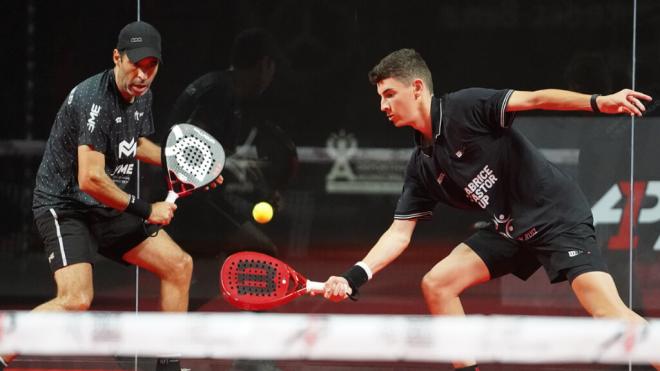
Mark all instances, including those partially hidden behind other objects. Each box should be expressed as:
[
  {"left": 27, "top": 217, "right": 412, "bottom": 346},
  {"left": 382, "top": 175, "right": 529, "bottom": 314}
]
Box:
[{"left": 465, "top": 222, "right": 607, "bottom": 283}]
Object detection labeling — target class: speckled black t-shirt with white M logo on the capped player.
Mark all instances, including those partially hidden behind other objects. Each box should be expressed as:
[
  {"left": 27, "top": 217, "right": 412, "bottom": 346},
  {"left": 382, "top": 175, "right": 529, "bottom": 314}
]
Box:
[{"left": 32, "top": 69, "right": 154, "bottom": 215}]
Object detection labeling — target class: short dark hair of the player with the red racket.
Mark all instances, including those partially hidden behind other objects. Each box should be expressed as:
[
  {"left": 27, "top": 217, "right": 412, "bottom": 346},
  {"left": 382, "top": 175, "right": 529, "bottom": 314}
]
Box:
[{"left": 369, "top": 49, "right": 433, "bottom": 93}]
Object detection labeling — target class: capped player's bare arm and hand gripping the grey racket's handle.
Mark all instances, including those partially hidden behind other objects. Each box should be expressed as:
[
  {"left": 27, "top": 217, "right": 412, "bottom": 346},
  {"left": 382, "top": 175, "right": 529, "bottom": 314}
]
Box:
[{"left": 78, "top": 145, "right": 176, "bottom": 224}]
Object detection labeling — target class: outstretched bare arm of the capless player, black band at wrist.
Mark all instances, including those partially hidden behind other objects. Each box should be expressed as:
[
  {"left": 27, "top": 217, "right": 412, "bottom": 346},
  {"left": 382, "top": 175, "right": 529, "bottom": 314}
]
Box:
[{"left": 506, "top": 89, "right": 652, "bottom": 116}]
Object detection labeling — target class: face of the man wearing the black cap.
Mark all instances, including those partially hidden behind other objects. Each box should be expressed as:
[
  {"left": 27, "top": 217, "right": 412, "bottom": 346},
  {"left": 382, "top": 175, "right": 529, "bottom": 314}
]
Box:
[{"left": 113, "top": 49, "right": 158, "bottom": 102}]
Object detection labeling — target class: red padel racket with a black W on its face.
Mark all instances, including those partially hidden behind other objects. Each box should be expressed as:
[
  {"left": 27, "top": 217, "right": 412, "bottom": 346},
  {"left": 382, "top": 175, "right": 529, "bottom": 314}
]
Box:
[{"left": 220, "top": 251, "right": 324, "bottom": 310}]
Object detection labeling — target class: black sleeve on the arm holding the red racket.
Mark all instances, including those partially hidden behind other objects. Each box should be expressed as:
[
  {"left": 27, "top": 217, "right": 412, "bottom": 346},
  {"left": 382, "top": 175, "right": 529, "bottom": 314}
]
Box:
[{"left": 394, "top": 151, "right": 437, "bottom": 220}]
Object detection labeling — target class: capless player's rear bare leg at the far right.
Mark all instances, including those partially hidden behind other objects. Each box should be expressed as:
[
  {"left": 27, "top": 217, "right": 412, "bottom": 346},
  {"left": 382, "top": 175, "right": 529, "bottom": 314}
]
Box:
[{"left": 571, "top": 272, "right": 660, "bottom": 370}]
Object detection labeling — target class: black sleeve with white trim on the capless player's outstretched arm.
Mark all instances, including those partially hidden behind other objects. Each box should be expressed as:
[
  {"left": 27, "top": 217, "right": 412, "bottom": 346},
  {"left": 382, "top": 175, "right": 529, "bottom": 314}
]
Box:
[{"left": 447, "top": 88, "right": 515, "bottom": 131}]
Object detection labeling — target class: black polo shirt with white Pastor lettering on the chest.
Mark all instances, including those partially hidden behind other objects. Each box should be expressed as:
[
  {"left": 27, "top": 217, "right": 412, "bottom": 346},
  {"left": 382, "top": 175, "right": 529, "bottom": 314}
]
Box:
[{"left": 394, "top": 88, "right": 591, "bottom": 241}]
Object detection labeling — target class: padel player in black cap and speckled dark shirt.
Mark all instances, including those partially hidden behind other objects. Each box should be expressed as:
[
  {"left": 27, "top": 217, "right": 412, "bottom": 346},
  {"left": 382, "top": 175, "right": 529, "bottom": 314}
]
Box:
[{"left": 2, "top": 22, "right": 221, "bottom": 371}]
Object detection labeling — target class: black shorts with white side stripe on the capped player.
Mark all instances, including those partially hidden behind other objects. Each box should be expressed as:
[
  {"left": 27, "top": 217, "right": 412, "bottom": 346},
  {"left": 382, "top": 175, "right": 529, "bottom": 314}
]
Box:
[{"left": 34, "top": 208, "right": 158, "bottom": 272}]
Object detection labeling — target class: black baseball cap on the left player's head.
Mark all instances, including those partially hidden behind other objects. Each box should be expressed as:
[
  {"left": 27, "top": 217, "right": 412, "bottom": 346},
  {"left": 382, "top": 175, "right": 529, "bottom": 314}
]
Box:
[{"left": 117, "top": 21, "right": 163, "bottom": 63}]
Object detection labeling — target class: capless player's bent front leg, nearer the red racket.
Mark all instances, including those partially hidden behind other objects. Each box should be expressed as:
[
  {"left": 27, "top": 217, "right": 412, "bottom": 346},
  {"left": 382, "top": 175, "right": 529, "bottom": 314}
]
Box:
[{"left": 422, "top": 243, "right": 490, "bottom": 368}]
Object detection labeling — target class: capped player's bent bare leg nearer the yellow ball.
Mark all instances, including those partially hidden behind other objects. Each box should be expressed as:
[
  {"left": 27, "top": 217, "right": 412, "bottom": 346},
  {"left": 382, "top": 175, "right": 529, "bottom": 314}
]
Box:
[{"left": 124, "top": 230, "right": 193, "bottom": 312}]
